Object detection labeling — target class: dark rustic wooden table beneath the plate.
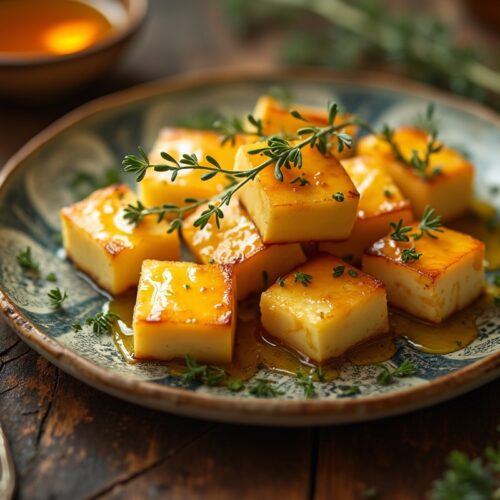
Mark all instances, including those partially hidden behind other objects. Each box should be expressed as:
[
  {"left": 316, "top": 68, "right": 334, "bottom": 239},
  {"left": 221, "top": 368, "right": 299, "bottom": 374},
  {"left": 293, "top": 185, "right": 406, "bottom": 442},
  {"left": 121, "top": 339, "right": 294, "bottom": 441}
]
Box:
[{"left": 0, "top": 0, "right": 500, "bottom": 500}]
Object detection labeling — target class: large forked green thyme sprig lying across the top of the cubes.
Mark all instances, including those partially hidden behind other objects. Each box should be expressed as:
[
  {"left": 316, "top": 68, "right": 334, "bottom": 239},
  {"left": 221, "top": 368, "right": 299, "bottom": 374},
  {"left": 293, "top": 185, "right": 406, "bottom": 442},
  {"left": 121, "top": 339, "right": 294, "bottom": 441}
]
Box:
[{"left": 123, "top": 103, "right": 358, "bottom": 232}]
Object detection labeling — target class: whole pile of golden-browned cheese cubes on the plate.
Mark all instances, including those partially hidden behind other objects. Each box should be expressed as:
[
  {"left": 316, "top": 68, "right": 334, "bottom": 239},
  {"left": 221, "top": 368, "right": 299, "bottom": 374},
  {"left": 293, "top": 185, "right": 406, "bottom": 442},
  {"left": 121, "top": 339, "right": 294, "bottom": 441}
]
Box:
[{"left": 61, "top": 96, "right": 485, "bottom": 363}]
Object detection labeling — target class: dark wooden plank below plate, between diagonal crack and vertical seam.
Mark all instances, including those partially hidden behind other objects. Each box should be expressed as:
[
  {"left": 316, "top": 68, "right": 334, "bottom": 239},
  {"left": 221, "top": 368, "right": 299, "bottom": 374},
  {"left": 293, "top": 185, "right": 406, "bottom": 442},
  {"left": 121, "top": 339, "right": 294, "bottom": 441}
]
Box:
[{"left": 98, "top": 425, "right": 312, "bottom": 500}]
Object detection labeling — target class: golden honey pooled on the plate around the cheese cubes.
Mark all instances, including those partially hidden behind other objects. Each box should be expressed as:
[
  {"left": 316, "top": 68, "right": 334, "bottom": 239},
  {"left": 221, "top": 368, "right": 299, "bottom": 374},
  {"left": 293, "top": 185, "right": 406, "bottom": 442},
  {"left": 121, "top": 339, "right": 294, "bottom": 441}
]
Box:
[{"left": 109, "top": 209, "right": 500, "bottom": 380}]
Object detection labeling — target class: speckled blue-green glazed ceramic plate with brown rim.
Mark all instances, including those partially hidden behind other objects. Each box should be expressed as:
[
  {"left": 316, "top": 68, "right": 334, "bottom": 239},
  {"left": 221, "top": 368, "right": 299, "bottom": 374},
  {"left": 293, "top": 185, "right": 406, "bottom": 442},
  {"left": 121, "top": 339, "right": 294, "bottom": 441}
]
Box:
[{"left": 0, "top": 70, "right": 500, "bottom": 425}]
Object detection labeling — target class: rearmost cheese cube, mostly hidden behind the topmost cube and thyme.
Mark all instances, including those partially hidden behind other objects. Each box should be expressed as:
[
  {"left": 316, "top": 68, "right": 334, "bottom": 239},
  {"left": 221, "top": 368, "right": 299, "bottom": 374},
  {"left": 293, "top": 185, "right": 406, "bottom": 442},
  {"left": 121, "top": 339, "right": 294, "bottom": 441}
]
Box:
[{"left": 254, "top": 95, "right": 357, "bottom": 158}]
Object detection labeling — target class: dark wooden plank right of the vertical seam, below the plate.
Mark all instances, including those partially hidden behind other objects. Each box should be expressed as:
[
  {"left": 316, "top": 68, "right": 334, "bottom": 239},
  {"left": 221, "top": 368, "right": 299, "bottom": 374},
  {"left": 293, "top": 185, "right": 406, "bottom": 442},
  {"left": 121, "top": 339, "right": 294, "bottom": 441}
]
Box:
[{"left": 315, "top": 380, "right": 500, "bottom": 500}]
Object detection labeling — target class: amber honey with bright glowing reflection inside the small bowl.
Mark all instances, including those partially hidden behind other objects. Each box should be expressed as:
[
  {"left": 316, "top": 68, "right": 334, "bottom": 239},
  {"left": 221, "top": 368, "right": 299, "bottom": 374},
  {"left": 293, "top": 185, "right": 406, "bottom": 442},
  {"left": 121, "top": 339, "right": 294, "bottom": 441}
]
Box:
[{"left": 0, "top": 0, "right": 114, "bottom": 58}]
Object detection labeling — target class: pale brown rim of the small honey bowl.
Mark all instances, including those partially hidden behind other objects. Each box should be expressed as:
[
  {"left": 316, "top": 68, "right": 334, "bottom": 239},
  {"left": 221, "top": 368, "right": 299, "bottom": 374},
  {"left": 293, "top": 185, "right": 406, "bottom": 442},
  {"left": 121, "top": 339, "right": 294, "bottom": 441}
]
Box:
[{"left": 0, "top": 0, "right": 149, "bottom": 70}]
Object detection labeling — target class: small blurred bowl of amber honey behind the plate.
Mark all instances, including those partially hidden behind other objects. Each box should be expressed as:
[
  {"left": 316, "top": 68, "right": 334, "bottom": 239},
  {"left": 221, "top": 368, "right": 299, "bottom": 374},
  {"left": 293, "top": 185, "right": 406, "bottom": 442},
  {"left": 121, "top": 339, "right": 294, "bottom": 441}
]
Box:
[{"left": 0, "top": 0, "right": 148, "bottom": 101}]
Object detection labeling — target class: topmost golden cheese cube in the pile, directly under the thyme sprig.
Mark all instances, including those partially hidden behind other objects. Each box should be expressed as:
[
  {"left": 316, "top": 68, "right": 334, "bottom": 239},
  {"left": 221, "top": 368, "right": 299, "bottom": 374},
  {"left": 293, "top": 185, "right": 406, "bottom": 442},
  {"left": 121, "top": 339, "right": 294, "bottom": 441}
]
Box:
[{"left": 235, "top": 142, "right": 359, "bottom": 243}]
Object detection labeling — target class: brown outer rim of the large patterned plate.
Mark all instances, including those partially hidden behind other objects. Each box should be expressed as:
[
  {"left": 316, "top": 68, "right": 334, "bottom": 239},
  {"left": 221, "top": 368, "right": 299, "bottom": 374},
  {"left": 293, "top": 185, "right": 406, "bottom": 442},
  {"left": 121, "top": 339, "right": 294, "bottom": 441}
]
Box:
[{"left": 0, "top": 67, "right": 500, "bottom": 426}]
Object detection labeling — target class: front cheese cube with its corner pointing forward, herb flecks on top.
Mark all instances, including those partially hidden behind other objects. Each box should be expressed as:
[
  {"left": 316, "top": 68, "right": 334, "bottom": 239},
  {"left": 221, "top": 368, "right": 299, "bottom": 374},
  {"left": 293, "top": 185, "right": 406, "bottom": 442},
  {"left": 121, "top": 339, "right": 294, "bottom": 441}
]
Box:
[{"left": 260, "top": 254, "right": 389, "bottom": 362}]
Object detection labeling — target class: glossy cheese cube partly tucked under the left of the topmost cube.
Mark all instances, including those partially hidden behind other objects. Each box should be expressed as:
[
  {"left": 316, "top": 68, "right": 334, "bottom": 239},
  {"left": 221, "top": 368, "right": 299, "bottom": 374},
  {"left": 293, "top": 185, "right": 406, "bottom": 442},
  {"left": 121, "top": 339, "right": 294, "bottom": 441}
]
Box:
[{"left": 182, "top": 198, "right": 306, "bottom": 300}]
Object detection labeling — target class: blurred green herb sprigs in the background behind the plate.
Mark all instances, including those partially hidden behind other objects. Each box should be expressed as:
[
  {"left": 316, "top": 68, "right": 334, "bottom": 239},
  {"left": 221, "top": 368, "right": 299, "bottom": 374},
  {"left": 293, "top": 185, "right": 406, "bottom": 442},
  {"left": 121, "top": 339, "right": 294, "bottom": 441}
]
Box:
[{"left": 220, "top": 0, "right": 500, "bottom": 110}]
